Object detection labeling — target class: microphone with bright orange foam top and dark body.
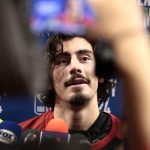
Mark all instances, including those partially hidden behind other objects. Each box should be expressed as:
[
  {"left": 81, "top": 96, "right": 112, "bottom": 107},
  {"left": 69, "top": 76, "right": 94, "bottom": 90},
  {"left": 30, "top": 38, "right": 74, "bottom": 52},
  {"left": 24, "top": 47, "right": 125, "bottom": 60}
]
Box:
[{"left": 40, "top": 119, "right": 70, "bottom": 150}]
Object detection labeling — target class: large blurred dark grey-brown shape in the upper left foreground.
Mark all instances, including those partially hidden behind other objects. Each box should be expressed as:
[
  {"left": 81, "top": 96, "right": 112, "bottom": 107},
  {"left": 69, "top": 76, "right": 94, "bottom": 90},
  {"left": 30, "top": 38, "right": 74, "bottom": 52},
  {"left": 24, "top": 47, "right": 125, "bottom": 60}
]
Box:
[{"left": 0, "top": 0, "right": 47, "bottom": 94}]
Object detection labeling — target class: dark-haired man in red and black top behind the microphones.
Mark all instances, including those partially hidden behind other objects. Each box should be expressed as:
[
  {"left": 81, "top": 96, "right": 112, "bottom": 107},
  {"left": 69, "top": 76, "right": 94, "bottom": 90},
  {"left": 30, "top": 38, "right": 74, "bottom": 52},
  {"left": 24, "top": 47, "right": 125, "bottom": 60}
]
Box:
[{"left": 20, "top": 33, "right": 122, "bottom": 149}]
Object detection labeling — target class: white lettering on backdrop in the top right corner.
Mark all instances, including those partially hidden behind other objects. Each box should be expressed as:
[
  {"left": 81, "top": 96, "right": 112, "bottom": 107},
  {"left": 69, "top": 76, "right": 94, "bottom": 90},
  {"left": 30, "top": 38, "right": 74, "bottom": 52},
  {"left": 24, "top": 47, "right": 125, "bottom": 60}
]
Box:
[{"left": 138, "top": 0, "right": 150, "bottom": 32}]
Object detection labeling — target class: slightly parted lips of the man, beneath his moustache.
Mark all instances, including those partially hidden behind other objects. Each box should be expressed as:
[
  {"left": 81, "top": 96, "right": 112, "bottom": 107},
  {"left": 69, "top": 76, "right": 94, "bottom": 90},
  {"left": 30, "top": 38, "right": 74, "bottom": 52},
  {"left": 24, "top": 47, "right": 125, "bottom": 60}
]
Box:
[{"left": 65, "top": 78, "right": 89, "bottom": 87}]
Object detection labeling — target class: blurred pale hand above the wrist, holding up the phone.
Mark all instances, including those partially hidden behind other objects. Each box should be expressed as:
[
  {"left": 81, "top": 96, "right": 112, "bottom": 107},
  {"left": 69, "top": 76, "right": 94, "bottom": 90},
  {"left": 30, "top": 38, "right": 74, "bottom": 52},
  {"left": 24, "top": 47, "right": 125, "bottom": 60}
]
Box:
[{"left": 88, "top": 0, "right": 144, "bottom": 39}]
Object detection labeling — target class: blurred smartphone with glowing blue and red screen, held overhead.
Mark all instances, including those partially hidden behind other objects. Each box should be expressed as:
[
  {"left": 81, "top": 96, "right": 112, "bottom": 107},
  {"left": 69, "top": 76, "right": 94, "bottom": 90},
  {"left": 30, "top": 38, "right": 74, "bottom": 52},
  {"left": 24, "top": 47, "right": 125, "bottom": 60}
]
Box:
[{"left": 29, "top": 0, "right": 96, "bottom": 34}]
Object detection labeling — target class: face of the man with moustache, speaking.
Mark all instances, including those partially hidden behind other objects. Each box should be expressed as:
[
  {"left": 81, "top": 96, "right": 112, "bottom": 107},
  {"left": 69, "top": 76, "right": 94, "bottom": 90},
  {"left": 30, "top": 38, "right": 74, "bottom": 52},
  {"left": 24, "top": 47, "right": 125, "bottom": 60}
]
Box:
[{"left": 52, "top": 37, "right": 98, "bottom": 105}]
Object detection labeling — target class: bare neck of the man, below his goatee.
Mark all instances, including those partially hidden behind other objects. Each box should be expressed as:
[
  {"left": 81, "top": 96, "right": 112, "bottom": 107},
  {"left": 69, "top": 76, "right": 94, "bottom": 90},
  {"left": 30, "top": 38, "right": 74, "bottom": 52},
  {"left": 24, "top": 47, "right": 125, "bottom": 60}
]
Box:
[{"left": 54, "top": 95, "right": 99, "bottom": 130}]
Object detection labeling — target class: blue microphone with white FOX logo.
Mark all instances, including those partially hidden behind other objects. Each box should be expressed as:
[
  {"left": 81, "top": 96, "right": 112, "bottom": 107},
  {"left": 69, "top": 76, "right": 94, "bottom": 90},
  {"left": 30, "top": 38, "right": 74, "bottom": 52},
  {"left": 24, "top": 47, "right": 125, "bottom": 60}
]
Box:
[{"left": 0, "top": 121, "right": 22, "bottom": 150}]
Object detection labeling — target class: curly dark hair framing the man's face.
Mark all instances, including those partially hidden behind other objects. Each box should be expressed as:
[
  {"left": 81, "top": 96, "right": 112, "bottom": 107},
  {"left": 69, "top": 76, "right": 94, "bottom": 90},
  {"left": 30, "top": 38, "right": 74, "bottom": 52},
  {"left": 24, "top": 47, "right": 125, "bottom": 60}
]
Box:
[{"left": 40, "top": 33, "right": 115, "bottom": 109}]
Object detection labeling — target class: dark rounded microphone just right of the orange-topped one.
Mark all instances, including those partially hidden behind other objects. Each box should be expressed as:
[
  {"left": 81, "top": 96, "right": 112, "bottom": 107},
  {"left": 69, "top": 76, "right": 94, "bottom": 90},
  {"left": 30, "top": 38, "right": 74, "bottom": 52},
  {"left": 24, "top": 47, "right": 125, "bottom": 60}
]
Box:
[{"left": 69, "top": 134, "right": 92, "bottom": 150}]
